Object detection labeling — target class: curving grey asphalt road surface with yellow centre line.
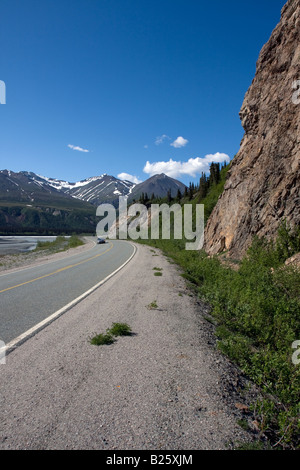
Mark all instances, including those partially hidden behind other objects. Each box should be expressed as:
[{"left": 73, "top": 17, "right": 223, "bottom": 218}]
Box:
[{"left": 0, "top": 240, "right": 134, "bottom": 344}]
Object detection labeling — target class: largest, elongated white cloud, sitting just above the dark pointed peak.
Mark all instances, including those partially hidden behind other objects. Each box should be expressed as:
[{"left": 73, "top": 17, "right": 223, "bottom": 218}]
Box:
[{"left": 143, "top": 152, "right": 230, "bottom": 178}]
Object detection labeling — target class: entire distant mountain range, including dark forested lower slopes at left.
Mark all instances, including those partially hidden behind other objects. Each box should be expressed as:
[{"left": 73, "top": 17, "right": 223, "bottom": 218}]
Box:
[{"left": 0, "top": 170, "right": 185, "bottom": 233}]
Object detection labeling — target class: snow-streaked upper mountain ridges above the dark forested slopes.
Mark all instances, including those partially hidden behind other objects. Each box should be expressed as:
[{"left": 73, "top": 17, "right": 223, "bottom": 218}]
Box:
[{"left": 0, "top": 170, "right": 185, "bottom": 207}]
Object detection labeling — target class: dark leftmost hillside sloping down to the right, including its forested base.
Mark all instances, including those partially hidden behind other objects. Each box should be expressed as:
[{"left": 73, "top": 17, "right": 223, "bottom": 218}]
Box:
[{"left": 0, "top": 170, "right": 96, "bottom": 234}]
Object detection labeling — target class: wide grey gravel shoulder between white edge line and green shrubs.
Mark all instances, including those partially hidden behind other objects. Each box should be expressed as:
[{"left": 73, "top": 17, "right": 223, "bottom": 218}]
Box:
[{"left": 0, "top": 241, "right": 258, "bottom": 450}]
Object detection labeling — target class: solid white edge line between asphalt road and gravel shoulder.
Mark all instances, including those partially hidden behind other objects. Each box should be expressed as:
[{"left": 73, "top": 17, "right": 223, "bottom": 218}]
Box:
[{"left": 0, "top": 242, "right": 137, "bottom": 359}]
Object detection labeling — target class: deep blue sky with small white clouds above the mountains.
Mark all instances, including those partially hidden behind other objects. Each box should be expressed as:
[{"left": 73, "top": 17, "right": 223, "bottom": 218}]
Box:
[{"left": 0, "top": 0, "right": 286, "bottom": 184}]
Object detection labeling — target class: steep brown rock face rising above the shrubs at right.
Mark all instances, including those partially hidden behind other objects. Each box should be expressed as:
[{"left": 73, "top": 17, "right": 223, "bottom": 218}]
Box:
[{"left": 205, "top": 0, "right": 300, "bottom": 258}]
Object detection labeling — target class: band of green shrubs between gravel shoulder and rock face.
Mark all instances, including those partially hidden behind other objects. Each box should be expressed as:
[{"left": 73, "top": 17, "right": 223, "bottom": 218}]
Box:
[{"left": 137, "top": 228, "right": 300, "bottom": 449}]
